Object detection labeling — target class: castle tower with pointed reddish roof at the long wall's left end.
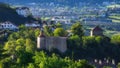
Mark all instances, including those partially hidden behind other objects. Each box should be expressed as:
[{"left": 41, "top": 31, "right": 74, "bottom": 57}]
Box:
[{"left": 37, "top": 31, "right": 46, "bottom": 49}]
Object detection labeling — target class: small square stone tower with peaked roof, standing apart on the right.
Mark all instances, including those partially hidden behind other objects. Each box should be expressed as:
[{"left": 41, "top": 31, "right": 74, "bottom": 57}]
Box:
[{"left": 90, "top": 26, "right": 103, "bottom": 36}]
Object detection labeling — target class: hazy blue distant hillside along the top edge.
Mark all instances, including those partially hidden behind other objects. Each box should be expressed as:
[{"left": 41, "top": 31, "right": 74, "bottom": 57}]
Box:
[{"left": 0, "top": 0, "right": 120, "bottom": 6}]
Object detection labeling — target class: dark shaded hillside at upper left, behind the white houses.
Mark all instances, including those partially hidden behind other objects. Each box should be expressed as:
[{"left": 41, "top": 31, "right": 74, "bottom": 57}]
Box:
[{"left": 0, "top": 3, "right": 34, "bottom": 25}]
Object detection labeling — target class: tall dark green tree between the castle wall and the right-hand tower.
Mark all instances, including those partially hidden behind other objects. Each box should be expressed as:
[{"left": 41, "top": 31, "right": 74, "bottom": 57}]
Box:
[{"left": 71, "top": 22, "right": 84, "bottom": 37}]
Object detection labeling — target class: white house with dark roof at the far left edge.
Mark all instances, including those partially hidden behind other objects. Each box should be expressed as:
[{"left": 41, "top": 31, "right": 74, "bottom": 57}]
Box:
[{"left": 0, "top": 21, "right": 18, "bottom": 30}]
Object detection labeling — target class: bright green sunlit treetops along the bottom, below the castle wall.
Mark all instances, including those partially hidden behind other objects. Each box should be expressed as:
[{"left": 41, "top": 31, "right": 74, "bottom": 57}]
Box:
[{"left": 31, "top": 51, "right": 94, "bottom": 68}]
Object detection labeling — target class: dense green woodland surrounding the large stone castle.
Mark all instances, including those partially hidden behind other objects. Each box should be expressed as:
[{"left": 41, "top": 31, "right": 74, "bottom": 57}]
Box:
[{"left": 0, "top": 22, "right": 120, "bottom": 68}]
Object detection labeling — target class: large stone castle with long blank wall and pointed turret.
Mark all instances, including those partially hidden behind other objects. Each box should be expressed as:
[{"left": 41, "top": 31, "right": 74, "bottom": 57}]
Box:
[{"left": 37, "top": 31, "right": 67, "bottom": 53}]
